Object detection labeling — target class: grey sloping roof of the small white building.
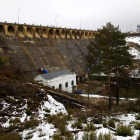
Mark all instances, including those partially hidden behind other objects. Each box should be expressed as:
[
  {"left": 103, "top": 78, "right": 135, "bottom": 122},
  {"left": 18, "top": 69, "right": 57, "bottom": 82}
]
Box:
[{"left": 40, "top": 70, "right": 73, "bottom": 80}]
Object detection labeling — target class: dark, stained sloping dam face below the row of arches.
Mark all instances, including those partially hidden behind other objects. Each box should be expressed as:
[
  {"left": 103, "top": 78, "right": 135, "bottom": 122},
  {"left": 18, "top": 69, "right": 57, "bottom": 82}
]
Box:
[{"left": 0, "top": 34, "right": 90, "bottom": 74}]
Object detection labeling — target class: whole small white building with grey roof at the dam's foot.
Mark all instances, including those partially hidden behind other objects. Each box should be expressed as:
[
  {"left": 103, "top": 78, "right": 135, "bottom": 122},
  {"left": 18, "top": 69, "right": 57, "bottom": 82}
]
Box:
[{"left": 34, "top": 70, "right": 76, "bottom": 93}]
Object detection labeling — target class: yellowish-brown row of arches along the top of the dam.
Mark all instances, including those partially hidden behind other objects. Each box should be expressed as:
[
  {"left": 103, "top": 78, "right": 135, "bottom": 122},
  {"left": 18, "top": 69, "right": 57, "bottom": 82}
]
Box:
[{"left": 0, "top": 22, "right": 95, "bottom": 39}]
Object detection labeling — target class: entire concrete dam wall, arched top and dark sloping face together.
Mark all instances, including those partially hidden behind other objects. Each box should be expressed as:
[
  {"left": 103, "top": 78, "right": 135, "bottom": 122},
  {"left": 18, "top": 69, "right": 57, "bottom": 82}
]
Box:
[{"left": 0, "top": 23, "right": 94, "bottom": 75}]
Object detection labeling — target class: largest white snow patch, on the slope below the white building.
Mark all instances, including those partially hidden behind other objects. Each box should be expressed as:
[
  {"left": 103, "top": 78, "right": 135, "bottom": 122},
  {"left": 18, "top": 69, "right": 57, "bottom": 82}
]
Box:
[{"left": 21, "top": 95, "right": 67, "bottom": 140}]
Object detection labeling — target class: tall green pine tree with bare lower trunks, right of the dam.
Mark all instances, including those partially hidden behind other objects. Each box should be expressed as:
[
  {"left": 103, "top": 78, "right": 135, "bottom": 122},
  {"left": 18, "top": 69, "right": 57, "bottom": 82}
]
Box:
[{"left": 87, "top": 22, "right": 133, "bottom": 108}]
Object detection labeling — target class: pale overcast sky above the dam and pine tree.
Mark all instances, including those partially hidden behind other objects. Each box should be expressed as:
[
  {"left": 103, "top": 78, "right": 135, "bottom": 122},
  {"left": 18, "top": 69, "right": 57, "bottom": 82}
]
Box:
[{"left": 0, "top": 0, "right": 140, "bottom": 32}]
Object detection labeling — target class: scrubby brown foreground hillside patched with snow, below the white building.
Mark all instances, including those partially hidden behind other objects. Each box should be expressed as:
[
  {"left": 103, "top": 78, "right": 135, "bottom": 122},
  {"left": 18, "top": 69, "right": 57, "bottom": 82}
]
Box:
[{"left": 0, "top": 76, "right": 140, "bottom": 140}]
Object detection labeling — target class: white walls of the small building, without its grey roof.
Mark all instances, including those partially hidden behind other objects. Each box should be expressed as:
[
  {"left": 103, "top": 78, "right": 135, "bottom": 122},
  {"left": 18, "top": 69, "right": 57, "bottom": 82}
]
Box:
[{"left": 34, "top": 74, "right": 76, "bottom": 93}]
